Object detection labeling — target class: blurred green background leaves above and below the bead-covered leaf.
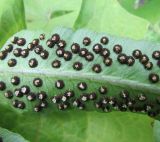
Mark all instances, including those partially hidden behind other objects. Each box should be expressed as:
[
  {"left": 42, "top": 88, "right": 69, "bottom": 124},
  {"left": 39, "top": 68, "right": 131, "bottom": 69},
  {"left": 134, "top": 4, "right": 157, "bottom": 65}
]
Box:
[{"left": 0, "top": 0, "right": 160, "bottom": 142}]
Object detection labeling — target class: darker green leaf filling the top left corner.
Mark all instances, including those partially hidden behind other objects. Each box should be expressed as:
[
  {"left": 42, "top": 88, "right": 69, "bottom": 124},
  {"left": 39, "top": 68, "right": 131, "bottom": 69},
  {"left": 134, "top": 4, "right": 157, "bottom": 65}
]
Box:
[{"left": 0, "top": 0, "right": 25, "bottom": 47}]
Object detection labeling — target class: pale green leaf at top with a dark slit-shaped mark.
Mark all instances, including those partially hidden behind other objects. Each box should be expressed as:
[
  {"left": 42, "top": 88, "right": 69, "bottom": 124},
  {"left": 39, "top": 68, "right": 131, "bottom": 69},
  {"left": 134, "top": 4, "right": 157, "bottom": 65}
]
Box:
[{"left": 24, "top": 0, "right": 82, "bottom": 31}]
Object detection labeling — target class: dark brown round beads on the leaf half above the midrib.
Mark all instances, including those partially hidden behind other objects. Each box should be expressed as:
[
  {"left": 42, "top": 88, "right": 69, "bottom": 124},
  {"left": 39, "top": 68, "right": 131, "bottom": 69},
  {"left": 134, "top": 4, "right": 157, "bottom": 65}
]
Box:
[{"left": 0, "top": 34, "right": 160, "bottom": 83}]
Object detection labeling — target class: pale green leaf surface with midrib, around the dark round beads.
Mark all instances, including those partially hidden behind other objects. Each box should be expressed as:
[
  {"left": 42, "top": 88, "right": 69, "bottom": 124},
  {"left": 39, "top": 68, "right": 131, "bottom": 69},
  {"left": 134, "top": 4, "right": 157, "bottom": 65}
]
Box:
[{"left": 0, "top": 28, "right": 160, "bottom": 119}]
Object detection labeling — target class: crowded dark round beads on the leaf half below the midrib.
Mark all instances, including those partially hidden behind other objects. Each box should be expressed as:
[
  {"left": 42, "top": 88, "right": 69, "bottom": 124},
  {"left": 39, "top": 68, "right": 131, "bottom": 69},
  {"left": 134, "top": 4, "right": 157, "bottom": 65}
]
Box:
[{"left": 0, "top": 79, "right": 160, "bottom": 117}]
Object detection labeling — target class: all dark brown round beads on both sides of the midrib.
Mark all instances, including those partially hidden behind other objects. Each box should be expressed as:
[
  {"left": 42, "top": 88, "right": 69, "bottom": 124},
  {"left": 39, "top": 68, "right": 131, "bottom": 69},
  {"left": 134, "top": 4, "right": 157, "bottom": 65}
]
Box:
[{"left": 0, "top": 33, "right": 160, "bottom": 116}]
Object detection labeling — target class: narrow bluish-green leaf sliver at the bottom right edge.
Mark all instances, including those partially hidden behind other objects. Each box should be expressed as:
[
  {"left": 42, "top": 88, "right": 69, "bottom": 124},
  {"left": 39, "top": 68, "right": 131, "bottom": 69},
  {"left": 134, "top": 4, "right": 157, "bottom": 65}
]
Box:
[{"left": 153, "top": 121, "right": 160, "bottom": 142}]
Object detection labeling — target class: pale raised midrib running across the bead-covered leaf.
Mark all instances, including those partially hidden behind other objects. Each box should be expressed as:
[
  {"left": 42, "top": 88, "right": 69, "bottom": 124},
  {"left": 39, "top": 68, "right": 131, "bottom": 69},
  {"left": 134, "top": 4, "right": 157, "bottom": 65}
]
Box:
[{"left": 0, "top": 69, "right": 160, "bottom": 95}]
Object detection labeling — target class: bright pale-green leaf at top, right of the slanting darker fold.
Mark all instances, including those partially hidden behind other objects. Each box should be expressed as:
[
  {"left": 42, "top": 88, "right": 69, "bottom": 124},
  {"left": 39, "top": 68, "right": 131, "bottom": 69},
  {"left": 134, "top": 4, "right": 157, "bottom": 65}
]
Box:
[{"left": 74, "top": 0, "right": 149, "bottom": 39}]
